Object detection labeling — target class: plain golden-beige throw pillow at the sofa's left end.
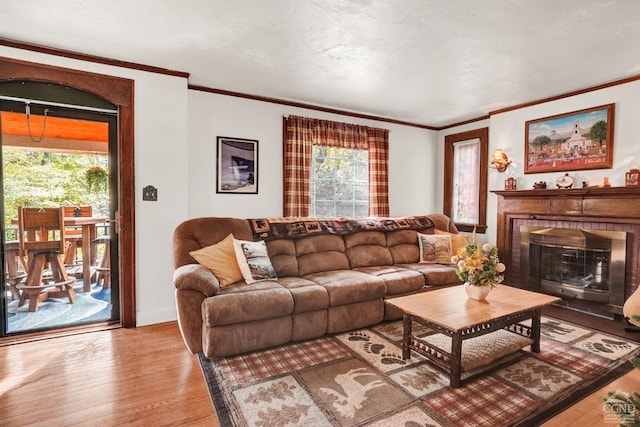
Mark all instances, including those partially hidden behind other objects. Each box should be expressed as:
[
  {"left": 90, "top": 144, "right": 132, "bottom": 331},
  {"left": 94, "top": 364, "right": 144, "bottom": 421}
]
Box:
[{"left": 189, "top": 234, "right": 243, "bottom": 287}]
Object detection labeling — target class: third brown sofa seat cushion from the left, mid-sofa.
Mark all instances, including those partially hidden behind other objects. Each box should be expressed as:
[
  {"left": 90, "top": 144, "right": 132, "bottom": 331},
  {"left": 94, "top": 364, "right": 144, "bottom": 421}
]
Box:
[{"left": 304, "top": 270, "right": 386, "bottom": 307}]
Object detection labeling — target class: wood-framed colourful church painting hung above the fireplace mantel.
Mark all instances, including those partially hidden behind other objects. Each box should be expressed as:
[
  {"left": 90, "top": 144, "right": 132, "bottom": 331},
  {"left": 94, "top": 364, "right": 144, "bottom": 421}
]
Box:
[{"left": 524, "top": 104, "right": 615, "bottom": 173}]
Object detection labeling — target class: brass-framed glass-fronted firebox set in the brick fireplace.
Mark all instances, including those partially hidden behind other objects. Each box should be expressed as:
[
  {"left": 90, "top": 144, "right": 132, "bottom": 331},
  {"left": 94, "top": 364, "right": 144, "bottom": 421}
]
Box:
[{"left": 520, "top": 226, "right": 627, "bottom": 306}]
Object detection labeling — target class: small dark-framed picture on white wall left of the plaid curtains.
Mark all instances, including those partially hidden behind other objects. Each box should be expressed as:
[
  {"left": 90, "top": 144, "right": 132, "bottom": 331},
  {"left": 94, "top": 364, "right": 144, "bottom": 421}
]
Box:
[{"left": 216, "top": 136, "right": 258, "bottom": 194}]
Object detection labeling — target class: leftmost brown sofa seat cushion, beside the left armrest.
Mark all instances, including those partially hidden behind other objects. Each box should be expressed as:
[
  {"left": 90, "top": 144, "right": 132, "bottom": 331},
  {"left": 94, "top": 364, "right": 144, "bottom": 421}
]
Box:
[{"left": 202, "top": 281, "right": 293, "bottom": 327}]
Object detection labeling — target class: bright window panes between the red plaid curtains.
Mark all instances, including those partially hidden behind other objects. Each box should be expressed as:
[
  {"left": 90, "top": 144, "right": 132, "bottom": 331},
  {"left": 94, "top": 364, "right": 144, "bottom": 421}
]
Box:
[{"left": 311, "top": 145, "right": 369, "bottom": 217}]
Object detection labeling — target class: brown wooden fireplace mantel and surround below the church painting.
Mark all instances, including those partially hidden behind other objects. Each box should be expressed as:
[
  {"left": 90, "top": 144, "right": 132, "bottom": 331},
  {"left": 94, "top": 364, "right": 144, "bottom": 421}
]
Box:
[{"left": 492, "top": 187, "right": 640, "bottom": 314}]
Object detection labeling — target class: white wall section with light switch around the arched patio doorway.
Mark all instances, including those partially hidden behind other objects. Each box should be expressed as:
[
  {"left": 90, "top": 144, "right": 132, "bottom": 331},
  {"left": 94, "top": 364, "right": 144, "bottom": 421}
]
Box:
[{"left": 0, "top": 46, "right": 189, "bottom": 325}]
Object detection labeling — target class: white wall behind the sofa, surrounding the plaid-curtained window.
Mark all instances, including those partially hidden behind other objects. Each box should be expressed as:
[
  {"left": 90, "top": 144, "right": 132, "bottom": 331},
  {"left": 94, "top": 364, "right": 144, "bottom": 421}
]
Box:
[{"left": 188, "top": 90, "right": 438, "bottom": 217}]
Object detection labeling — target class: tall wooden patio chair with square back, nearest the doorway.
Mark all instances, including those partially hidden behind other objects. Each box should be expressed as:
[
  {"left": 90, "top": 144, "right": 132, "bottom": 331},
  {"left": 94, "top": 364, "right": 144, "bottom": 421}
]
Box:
[{"left": 16, "top": 207, "right": 76, "bottom": 311}]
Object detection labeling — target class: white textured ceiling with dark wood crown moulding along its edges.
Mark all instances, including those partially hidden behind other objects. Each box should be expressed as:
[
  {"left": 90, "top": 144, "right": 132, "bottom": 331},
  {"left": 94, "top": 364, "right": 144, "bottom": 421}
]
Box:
[{"left": 0, "top": 0, "right": 640, "bottom": 127}]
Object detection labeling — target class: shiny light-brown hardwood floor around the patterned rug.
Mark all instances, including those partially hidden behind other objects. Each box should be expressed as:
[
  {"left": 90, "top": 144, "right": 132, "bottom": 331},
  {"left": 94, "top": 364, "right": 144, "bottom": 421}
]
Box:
[{"left": 0, "top": 322, "right": 640, "bottom": 427}]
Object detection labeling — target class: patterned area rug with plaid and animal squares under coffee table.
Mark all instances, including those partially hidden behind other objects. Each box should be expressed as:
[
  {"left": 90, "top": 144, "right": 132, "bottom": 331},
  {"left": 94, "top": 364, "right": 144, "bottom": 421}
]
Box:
[{"left": 199, "top": 317, "right": 639, "bottom": 427}]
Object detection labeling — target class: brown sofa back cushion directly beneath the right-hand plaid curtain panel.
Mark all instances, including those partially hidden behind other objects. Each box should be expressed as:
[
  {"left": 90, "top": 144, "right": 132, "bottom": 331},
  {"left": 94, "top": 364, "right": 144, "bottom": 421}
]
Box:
[{"left": 344, "top": 231, "right": 393, "bottom": 268}]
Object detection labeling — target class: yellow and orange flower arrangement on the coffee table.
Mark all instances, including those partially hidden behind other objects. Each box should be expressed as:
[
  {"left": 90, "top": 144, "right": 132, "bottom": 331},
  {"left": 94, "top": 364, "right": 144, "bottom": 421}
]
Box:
[{"left": 451, "top": 229, "right": 506, "bottom": 288}]
